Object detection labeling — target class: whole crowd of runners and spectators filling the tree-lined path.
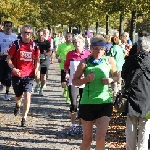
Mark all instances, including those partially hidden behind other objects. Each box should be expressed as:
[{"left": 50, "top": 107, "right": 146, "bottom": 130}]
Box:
[{"left": 0, "top": 21, "right": 150, "bottom": 150}]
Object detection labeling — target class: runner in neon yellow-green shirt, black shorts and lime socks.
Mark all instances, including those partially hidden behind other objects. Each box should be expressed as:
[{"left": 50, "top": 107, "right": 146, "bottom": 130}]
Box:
[{"left": 56, "top": 33, "right": 74, "bottom": 104}]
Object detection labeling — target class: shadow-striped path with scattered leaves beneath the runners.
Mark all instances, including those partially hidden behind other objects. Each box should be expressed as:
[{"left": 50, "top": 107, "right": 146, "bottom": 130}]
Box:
[{"left": 0, "top": 62, "right": 126, "bottom": 150}]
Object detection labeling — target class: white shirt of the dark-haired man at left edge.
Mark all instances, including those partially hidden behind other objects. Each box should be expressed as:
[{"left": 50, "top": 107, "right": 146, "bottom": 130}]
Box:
[{"left": 0, "top": 32, "right": 17, "bottom": 55}]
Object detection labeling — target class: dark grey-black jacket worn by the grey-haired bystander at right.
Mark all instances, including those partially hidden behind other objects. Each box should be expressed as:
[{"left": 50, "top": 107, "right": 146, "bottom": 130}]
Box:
[{"left": 122, "top": 52, "right": 150, "bottom": 117}]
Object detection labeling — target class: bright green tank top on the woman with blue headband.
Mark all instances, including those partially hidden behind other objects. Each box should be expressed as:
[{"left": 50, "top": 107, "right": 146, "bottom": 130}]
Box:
[{"left": 80, "top": 56, "right": 112, "bottom": 104}]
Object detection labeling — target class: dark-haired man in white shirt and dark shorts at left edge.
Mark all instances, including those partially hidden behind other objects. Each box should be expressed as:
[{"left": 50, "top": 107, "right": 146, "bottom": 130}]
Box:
[{"left": 0, "top": 21, "right": 17, "bottom": 101}]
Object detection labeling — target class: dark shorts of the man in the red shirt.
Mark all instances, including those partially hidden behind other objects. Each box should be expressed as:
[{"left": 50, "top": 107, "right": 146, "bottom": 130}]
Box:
[{"left": 12, "top": 76, "right": 34, "bottom": 97}]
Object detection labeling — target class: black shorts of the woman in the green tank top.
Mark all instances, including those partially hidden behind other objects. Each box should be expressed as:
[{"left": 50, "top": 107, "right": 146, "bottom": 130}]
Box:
[{"left": 79, "top": 103, "right": 113, "bottom": 121}]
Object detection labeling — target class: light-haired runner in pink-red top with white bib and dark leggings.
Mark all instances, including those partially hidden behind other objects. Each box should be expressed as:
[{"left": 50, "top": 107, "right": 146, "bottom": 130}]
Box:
[{"left": 64, "top": 35, "right": 90, "bottom": 135}]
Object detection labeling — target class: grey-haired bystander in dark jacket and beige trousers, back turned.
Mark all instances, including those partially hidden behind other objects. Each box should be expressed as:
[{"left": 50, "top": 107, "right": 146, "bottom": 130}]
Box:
[{"left": 122, "top": 37, "right": 150, "bottom": 150}]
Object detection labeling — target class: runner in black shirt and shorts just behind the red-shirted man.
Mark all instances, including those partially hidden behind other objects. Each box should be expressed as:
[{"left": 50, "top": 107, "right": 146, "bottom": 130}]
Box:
[{"left": 34, "top": 30, "right": 51, "bottom": 96}]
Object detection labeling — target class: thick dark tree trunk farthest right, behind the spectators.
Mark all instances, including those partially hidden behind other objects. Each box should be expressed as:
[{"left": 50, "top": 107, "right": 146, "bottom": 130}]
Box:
[{"left": 130, "top": 11, "right": 136, "bottom": 43}]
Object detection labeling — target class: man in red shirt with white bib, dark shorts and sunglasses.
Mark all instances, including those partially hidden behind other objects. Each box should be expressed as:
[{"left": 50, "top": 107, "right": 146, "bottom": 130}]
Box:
[{"left": 7, "top": 25, "right": 40, "bottom": 127}]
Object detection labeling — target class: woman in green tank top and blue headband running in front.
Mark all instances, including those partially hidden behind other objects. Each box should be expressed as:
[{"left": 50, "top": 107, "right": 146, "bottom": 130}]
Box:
[{"left": 73, "top": 35, "right": 118, "bottom": 150}]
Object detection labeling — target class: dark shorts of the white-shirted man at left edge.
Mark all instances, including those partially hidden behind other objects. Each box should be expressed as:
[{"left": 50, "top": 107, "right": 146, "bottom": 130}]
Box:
[{"left": 0, "top": 60, "right": 11, "bottom": 87}]
